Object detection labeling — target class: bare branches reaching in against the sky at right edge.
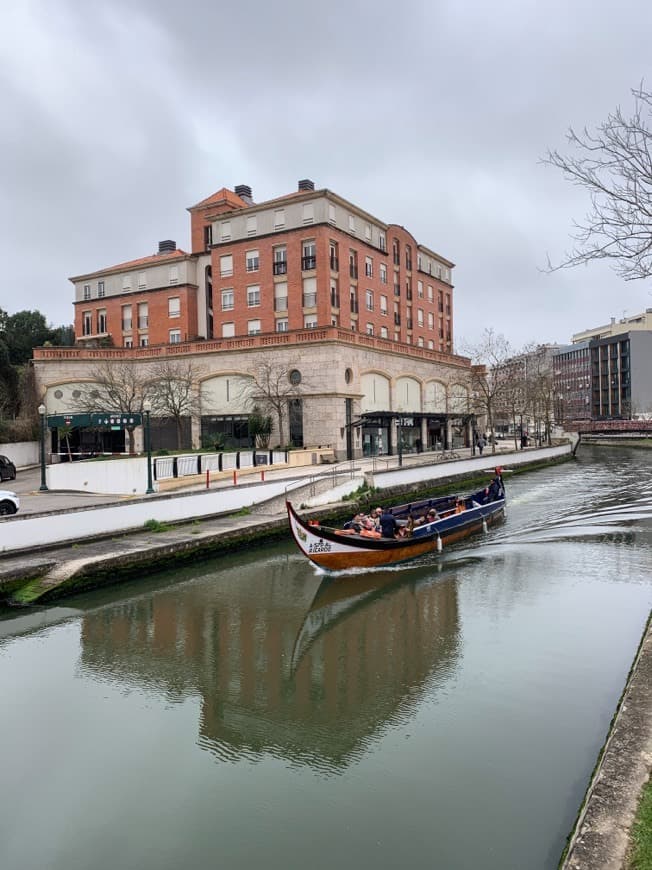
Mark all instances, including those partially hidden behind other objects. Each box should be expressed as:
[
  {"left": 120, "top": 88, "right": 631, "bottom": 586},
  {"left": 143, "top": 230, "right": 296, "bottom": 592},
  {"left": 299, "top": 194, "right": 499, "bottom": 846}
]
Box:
[{"left": 543, "top": 86, "right": 652, "bottom": 281}]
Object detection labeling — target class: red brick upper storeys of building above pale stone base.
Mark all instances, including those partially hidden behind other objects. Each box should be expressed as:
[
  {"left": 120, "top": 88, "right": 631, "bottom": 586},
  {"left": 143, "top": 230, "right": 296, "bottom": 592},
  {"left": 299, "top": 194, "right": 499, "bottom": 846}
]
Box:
[{"left": 71, "top": 179, "right": 453, "bottom": 353}]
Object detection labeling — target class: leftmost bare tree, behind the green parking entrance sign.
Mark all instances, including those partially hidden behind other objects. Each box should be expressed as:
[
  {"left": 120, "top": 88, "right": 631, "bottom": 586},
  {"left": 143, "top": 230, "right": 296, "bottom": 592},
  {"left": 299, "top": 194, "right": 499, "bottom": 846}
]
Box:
[{"left": 71, "top": 360, "right": 155, "bottom": 453}]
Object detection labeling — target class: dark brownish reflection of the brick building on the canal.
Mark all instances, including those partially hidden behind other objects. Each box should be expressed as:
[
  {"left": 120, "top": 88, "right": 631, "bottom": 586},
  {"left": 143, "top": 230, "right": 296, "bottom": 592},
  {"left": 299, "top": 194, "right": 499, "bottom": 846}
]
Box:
[{"left": 81, "top": 556, "right": 459, "bottom": 770}]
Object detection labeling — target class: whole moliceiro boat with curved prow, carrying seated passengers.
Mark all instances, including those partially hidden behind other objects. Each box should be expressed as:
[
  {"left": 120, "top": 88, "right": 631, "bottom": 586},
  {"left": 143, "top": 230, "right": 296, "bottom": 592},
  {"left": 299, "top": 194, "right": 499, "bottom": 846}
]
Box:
[{"left": 286, "top": 468, "right": 505, "bottom": 571}]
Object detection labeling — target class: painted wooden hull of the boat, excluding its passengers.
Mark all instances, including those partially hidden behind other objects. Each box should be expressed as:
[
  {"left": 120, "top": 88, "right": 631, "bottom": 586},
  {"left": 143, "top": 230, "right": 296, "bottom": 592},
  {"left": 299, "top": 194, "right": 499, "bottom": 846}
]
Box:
[{"left": 287, "top": 499, "right": 505, "bottom": 571}]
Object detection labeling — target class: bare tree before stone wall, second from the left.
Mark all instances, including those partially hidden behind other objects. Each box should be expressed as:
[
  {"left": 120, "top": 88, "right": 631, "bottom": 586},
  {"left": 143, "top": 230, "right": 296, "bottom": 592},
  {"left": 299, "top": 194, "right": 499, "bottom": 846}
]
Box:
[{"left": 148, "top": 359, "right": 203, "bottom": 449}]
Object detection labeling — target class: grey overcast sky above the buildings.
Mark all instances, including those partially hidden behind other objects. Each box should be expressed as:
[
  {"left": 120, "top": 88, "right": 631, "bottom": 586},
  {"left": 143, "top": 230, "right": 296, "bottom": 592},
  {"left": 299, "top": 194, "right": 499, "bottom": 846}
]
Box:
[{"left": 0, "top": 0, "right": 652, "bottom": 349}]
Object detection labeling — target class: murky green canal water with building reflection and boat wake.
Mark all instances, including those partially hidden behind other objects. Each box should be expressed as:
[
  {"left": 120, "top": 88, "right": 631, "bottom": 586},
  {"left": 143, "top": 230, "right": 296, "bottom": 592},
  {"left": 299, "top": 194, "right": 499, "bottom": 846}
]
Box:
[{"left": 0, "top": 447, "right": 652, "bottom": 870}]
